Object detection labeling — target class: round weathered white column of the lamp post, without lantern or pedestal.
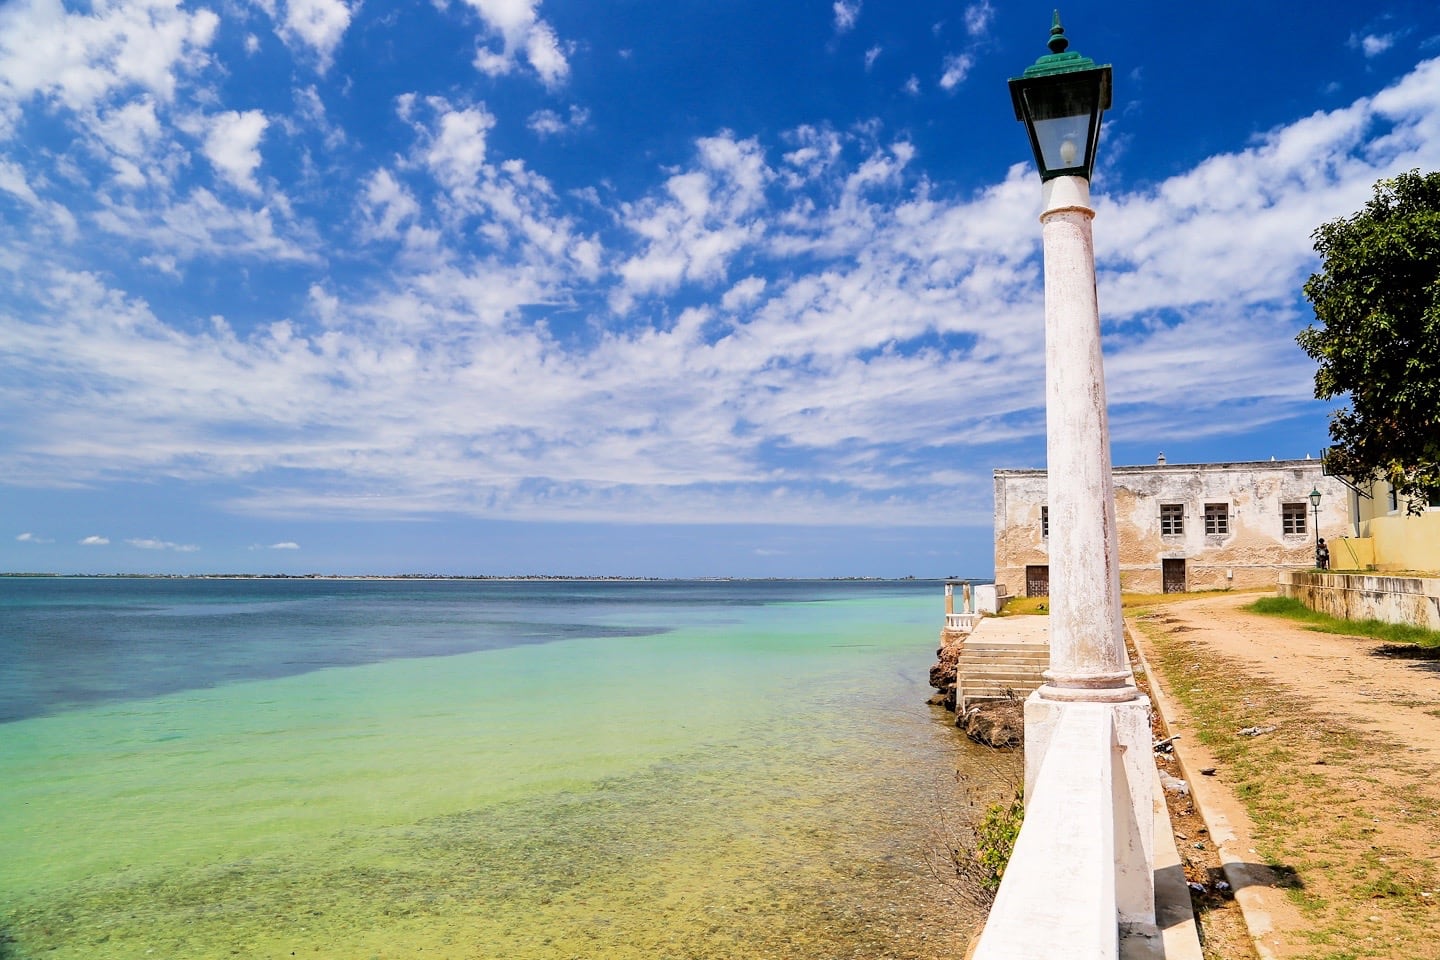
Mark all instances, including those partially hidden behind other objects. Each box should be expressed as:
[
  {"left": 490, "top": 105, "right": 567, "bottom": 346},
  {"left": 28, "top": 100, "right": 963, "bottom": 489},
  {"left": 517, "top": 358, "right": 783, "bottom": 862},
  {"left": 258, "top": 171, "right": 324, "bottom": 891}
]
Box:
[{"left": 1040, "top": 176, "right": 1138, "bottom": 702}]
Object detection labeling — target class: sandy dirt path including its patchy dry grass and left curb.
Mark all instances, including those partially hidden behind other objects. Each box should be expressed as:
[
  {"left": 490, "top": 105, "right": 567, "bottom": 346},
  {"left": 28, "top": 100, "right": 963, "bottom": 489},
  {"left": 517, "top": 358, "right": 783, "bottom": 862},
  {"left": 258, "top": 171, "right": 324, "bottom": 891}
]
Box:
[{"left": 1130, "top": 594, "right": 1440, "bottom": 960}]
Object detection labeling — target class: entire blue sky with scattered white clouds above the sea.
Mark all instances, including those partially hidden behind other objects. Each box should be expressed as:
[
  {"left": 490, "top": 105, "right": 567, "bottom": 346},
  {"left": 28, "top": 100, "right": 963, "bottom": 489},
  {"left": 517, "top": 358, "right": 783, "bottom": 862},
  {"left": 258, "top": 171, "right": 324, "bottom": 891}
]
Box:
[{"left": 0, "top": 0, "right": 1440, "bottom": 577}]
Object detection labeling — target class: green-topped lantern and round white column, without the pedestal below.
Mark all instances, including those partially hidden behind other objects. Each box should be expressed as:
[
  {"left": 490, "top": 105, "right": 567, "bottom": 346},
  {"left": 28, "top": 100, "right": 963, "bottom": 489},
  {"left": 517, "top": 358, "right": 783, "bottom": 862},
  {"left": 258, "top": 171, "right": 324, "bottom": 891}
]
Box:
[{"left": 1009, "top": 13, "right": 1136, "bottom": 702}]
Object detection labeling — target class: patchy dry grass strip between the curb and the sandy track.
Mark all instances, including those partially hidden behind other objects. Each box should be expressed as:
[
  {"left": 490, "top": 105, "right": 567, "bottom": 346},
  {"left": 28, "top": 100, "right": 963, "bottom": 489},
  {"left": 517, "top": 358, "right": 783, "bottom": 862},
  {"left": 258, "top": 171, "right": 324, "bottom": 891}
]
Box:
[{"left": 1135, "top": 609, "right": 1440, "bottom": 960}]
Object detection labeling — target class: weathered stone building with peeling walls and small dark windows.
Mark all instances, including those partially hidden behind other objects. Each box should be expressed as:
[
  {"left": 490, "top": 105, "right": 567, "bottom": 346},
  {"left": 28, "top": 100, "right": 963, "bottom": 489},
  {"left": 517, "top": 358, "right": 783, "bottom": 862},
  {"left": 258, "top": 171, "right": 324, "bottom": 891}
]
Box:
[{"left": 995, "top": 456, "right": 1354, "bottom": 596}]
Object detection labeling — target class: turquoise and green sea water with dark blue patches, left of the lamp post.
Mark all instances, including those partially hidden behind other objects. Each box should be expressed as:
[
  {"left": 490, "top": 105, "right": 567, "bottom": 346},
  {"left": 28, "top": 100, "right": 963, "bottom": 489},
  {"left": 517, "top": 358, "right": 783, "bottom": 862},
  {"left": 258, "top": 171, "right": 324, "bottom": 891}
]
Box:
[{"left": 0, "top": 579, "right": 996, "bottom": 960}]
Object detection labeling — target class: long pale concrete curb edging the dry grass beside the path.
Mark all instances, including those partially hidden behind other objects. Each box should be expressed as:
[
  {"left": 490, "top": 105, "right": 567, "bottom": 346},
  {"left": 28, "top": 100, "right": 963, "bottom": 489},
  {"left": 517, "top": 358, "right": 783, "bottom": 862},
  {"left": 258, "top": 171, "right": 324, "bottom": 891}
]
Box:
[{"left": 1125, "top": 622, "right": 1284, "bottom": 960}]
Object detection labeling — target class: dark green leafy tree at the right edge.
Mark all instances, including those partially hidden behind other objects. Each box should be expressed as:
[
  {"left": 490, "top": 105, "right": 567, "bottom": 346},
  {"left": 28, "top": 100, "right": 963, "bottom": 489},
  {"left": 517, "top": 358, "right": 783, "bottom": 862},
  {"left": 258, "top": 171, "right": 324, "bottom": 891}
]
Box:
[{"left": 1296, "top": 170, "right": 1440, "bottom": 512}]
